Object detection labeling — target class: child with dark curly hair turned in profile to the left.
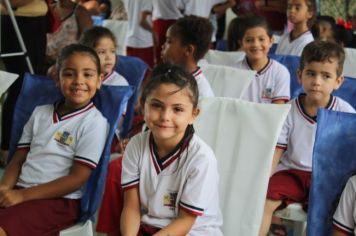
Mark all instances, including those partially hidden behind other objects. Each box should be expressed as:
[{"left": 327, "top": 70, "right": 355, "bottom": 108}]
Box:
[{"left": 161, "top": 16, "right": 214, "bottom": 97}]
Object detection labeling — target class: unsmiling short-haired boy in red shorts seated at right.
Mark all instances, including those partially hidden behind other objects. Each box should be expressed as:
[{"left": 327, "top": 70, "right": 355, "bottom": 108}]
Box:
[{"left": 259, "top": 41, "right": 355, "bottom": 236}]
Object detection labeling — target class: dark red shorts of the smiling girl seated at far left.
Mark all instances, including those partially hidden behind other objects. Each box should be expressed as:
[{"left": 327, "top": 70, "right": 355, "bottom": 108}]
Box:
[{"left": 0, "top": 198, "right": 80, "bottom": 236}]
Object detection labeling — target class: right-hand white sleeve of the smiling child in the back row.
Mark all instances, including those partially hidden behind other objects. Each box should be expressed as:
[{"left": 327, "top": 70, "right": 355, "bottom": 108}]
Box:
[{"left": 272, "top": 64, "right": 290, "bottom": 101}]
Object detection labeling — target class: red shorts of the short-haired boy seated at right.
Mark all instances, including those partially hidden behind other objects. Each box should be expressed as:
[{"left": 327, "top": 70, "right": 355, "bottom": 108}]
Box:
[{"left": 267, "top": 170, "right": 311, "bottom": 210}]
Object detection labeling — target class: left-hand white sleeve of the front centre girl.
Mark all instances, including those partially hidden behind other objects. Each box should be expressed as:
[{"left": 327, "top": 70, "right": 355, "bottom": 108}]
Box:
[{"left": 121, "top": 134, "right": 142, "bottom": 190}]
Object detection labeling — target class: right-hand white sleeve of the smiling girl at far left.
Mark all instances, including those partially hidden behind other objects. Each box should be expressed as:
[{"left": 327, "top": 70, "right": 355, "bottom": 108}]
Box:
[{"left": 74, "top": 114, "right": 109, "bottom": 169}]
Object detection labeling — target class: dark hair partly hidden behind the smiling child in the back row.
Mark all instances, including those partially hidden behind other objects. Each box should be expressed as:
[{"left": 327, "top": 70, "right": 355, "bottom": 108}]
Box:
[{"left": 227, "top": 17, "right": 245, "bottom": 51}]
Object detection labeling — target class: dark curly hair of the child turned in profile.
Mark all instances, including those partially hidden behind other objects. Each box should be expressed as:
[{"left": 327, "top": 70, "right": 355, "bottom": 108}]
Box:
[{"left": 171, "top": 16, "right": 213, "bottom": 62}]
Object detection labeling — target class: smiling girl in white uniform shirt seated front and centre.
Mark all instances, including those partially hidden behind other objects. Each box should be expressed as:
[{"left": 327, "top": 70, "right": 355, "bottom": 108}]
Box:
[{"left": 121, "top": 64, "right": 222, "bottom": 236}]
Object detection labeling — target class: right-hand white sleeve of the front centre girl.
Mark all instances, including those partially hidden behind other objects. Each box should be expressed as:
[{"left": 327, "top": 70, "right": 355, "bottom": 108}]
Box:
[{"left": 179, "top": 151, "right": 219, "bottom": 216}]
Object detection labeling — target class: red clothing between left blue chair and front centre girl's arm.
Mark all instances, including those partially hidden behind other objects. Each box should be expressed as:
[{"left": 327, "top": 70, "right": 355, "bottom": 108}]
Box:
[{"left": 96, "top": 157, "right": 124, "bottom": 235}]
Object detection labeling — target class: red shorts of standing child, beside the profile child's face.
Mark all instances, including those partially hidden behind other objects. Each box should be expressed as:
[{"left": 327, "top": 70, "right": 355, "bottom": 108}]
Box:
[{"left": 152, "top": 19, "right": 176, "bottom": 64}]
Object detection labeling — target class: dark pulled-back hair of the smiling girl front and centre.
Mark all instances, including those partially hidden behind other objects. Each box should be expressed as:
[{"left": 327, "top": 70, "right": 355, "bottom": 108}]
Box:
[{"left": 140, "top": 63, "right": 199, "bottom": 108}]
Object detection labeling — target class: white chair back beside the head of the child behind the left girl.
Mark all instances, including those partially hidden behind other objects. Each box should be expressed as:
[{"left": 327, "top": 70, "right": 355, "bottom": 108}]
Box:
[{"left": 103, "top": 20, "right": 128, "bottom": 55}]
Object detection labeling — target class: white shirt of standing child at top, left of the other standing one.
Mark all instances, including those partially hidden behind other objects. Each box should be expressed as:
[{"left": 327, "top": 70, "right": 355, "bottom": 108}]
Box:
[{"left": 123, "top": 0, "right": 153, "bottom": 48}]
